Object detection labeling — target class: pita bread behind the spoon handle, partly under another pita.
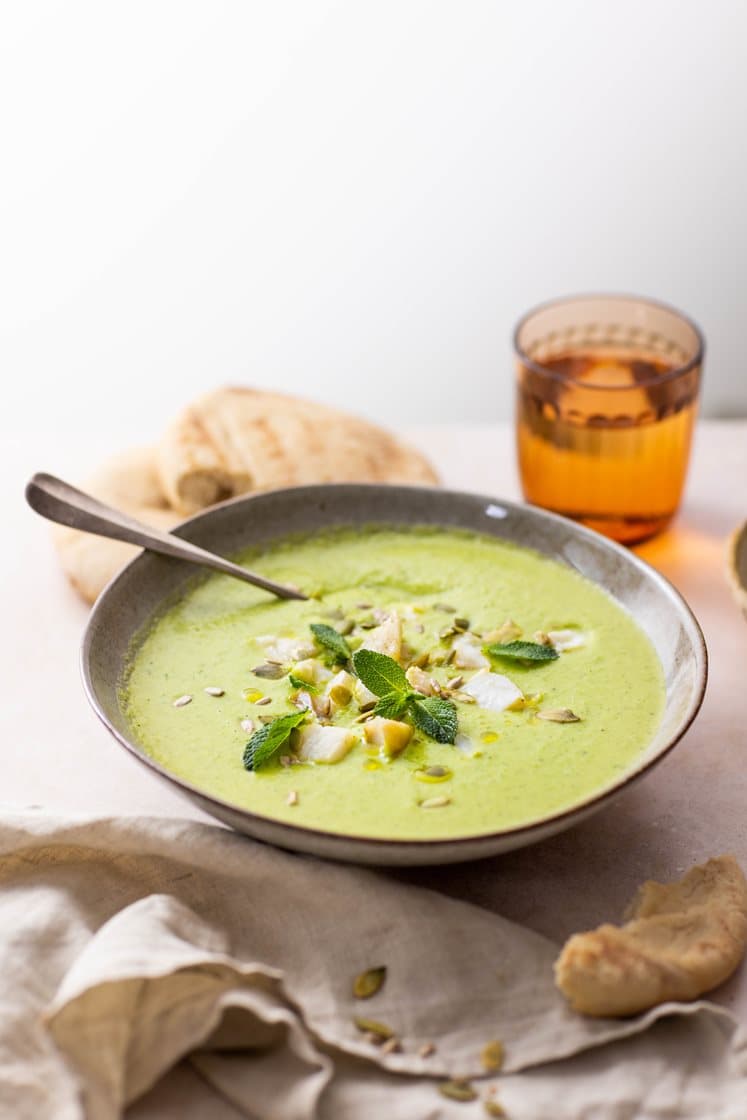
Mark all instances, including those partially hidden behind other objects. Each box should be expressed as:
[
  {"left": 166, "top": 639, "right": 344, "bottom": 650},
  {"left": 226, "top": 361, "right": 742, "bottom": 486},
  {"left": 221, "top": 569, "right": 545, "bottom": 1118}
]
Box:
[{"left": 53, "top": 449, "right": 180, "bottom": 603}]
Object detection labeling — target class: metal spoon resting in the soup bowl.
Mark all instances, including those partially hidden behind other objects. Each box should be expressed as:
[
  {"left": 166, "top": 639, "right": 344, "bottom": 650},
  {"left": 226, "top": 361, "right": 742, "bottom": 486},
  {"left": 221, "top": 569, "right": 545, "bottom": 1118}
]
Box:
[{"left": 26, "top": 474, "right": 308, "bottom": 599}]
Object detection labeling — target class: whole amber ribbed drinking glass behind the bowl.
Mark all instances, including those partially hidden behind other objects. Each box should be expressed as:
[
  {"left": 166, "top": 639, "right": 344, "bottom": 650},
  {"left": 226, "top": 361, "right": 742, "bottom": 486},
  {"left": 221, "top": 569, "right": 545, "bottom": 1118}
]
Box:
[{"left": 514, "top": 296, "right": 703, "bottom": 544}]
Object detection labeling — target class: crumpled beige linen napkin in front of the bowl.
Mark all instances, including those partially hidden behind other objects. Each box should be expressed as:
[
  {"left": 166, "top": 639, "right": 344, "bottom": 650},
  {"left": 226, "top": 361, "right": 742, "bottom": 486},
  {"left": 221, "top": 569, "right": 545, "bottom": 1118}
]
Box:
[{"left": 0, "top": 812, "right": 747, "bottom": 1120}]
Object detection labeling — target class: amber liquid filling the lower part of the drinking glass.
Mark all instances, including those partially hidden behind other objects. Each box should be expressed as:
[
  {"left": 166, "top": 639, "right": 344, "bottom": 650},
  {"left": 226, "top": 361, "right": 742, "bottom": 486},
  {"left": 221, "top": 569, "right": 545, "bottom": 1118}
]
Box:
[{"left": 517, "top": 347, "right": 698, "bottom": 543}]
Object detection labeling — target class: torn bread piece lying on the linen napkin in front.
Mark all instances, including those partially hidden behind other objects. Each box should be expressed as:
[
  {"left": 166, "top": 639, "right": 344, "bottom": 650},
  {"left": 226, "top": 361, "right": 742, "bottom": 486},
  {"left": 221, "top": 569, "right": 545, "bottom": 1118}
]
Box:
[{"left": 555, "top": 856, "right": 747, "bottom": 1016}]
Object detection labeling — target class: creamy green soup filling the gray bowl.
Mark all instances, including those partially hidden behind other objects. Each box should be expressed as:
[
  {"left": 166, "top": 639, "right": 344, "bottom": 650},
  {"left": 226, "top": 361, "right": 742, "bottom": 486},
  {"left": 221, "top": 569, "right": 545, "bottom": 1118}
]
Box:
[{"left": 121, "top": 528, "right": 664, "bottom": 839}]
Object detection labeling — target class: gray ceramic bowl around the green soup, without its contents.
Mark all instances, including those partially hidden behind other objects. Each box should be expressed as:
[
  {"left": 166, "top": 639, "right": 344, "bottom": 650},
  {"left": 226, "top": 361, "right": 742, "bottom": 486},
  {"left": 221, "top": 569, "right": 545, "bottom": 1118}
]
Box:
[{"left": 82, "top": 484, "right": 708, "bottom": 866}]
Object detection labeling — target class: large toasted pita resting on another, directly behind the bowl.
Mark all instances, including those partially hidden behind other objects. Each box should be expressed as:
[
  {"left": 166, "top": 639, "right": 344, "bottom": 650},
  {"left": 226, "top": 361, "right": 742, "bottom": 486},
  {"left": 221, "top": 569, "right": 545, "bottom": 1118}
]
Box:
[{"left": 157, "top": 389, "right": 438, "bottom": 515}]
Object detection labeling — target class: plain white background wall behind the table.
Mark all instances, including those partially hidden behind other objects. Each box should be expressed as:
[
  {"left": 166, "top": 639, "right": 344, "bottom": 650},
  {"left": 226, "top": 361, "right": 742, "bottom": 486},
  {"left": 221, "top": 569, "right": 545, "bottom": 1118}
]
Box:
[{"left": 0, "top": 0, "right": 747, "bottom": 445}]
